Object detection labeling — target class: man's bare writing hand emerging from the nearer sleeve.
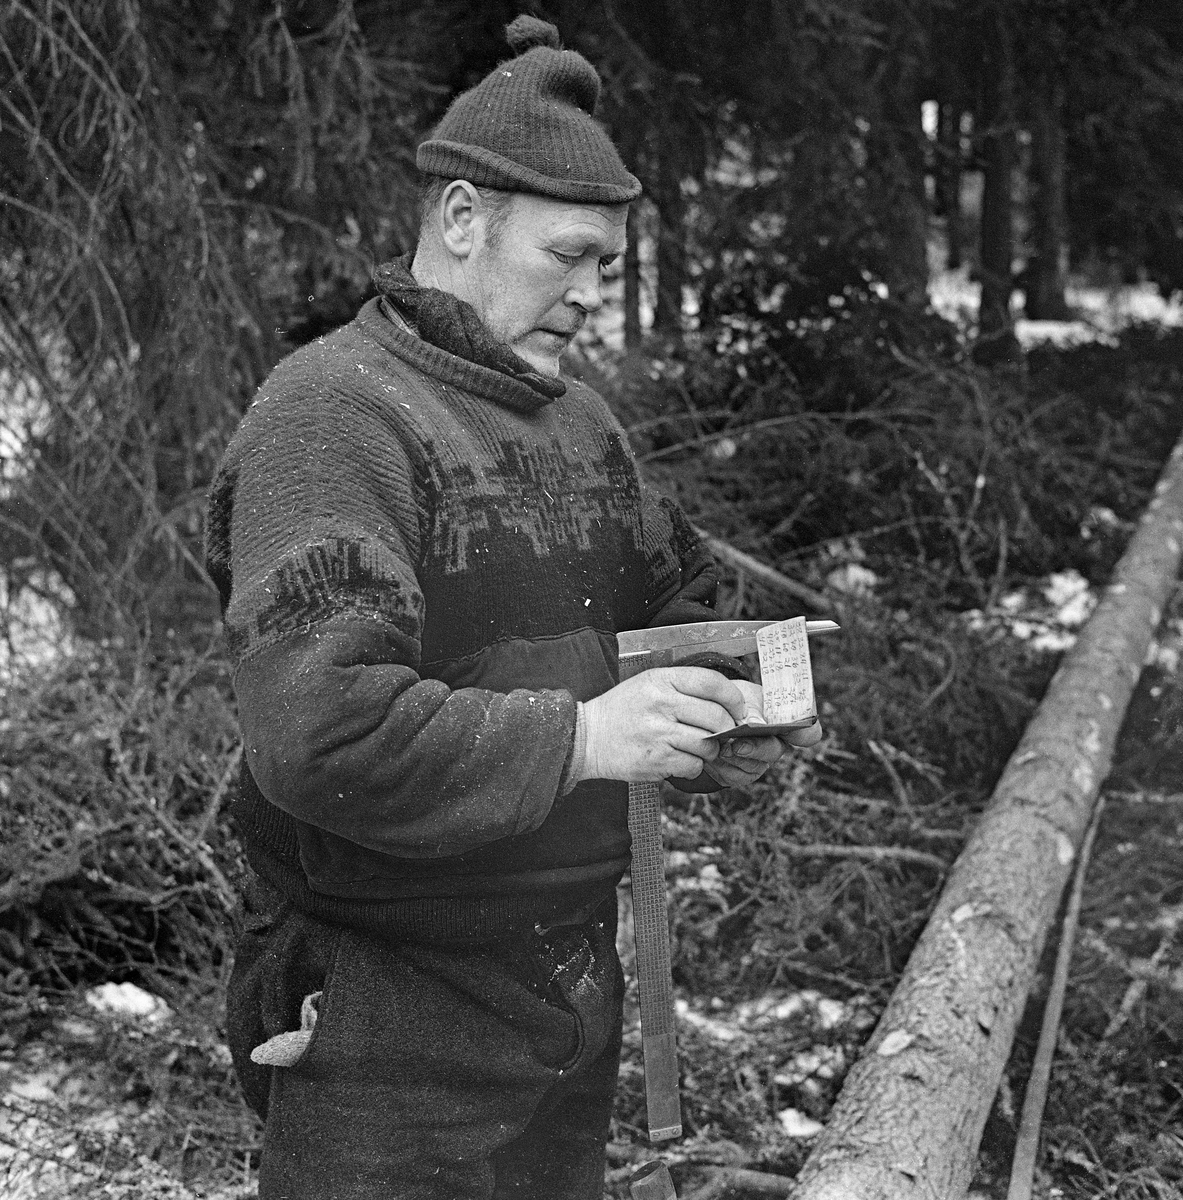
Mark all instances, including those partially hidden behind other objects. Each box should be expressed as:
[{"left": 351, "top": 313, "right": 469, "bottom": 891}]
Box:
[{"left": 576, "top": 667, "right": 746, "bottom": 784}]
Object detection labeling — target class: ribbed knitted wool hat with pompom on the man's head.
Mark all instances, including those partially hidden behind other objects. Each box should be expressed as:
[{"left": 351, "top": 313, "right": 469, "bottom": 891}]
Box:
[{"left": 415, "top": 13, "right": 641, "bottom": 204}]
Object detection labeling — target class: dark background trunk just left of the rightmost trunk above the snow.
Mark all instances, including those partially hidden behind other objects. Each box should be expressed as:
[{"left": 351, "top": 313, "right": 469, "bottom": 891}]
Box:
[{"left": 975, "top": 4, "right": 1017, "bottom": 361}]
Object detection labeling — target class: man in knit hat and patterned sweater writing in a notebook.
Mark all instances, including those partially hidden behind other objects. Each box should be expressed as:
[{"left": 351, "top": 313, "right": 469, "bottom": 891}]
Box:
[{"left": 209, "top": 17, "right": 818, "bottom": 1200}]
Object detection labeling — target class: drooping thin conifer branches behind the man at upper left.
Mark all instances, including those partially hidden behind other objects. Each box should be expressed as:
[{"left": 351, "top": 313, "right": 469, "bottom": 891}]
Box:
[{"left": 0, "top": 0, "right": 431, "bottom": 640}]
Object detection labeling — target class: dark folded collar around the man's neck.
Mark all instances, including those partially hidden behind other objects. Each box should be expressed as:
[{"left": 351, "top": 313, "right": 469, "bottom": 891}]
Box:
[{"left": 373, "top": 254, "right": 566, "bottom": 410}]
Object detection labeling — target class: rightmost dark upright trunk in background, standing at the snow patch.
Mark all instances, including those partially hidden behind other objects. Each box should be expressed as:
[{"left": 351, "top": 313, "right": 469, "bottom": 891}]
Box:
[{"left": 1026, "top": 79, "right": 1071, "bottom": 320}]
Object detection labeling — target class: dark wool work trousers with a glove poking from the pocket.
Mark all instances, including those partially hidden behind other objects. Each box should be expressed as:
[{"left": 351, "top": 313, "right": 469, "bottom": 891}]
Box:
[{"left": 227, "top": 878, "right": 623, "bottom": 1200}]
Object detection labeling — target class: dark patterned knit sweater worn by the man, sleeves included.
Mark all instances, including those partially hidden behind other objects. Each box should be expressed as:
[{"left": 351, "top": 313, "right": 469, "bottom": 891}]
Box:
[{"left": 208, "top": 300, "right": 715, "bottom": 940}]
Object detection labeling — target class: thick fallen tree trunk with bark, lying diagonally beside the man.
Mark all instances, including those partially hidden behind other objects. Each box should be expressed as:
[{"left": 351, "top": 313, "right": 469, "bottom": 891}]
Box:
[{"left": 793, "top": 442, "right": 1183, "bottom": 1200}]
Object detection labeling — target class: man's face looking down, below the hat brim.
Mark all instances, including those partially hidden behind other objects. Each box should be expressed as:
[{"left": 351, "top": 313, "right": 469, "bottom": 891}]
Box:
[{"left": 466, "top": 193, "right": 627, "bottom": 374}]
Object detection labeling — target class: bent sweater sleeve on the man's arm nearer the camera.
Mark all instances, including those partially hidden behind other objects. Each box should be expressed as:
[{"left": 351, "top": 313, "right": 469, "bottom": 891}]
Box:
[{"left": 219, "top": 369, "right": 575, "bottom": 857}]
